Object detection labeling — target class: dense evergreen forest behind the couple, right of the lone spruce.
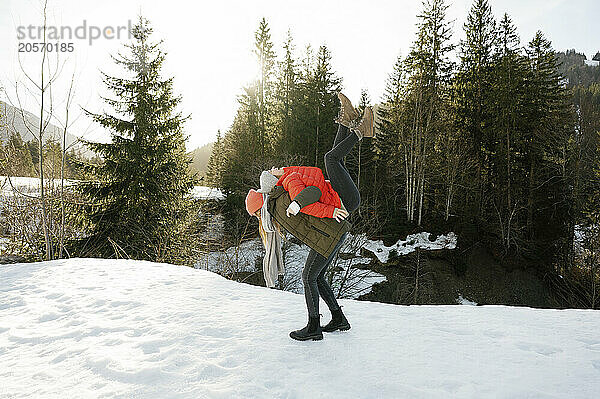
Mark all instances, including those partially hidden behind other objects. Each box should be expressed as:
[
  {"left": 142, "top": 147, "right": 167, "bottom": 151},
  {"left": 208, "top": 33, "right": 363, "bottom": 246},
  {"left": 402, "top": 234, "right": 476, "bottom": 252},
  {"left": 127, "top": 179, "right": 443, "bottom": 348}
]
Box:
[{"left": 207, "top": 0, "right": 600, "bottom": 300}]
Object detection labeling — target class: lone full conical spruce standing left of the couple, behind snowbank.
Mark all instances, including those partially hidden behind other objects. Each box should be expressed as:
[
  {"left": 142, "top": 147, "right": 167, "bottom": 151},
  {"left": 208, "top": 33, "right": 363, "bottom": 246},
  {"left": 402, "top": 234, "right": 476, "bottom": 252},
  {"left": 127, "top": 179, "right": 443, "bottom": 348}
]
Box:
[{"left": 79, "top": 17, "right": 194, "bottom": 260}]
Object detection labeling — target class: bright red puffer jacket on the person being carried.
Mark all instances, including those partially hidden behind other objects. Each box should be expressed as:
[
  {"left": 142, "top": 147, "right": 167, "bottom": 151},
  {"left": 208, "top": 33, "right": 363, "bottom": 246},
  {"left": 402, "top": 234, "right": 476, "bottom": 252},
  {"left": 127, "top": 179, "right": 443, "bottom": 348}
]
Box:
[{"left": 276, "top": 166, "right": 342, "bottom": 218}]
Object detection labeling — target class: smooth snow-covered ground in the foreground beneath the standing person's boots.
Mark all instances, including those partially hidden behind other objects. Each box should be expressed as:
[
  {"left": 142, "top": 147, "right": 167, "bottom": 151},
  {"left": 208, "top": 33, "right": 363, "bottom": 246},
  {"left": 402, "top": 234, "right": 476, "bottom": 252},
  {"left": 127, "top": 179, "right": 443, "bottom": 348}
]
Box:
[{"left": 0, "top": 259, "right": 600, "bottom": 399}]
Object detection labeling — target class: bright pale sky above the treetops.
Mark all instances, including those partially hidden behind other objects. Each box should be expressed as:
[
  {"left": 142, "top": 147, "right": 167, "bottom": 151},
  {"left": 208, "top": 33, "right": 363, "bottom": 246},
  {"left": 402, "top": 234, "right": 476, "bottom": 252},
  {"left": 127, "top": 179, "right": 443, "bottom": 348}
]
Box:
[{"left": 0, "top": 0, "right": 600, "bottom": 150}]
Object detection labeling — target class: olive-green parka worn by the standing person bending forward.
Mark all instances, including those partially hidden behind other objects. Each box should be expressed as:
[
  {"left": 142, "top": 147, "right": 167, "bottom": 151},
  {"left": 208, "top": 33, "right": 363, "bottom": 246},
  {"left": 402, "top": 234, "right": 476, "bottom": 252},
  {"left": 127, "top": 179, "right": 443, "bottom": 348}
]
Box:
[{"left": 267, "top": 186, "right": 351, "bottom": 258}]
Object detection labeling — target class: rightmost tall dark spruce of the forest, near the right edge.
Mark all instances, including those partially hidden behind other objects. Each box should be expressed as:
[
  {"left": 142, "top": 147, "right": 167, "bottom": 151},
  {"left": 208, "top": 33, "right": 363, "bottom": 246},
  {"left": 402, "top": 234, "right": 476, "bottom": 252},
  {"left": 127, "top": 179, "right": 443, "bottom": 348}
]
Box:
[{"left": 525, "top": 31, "right": 574, "bottom": 259}]
